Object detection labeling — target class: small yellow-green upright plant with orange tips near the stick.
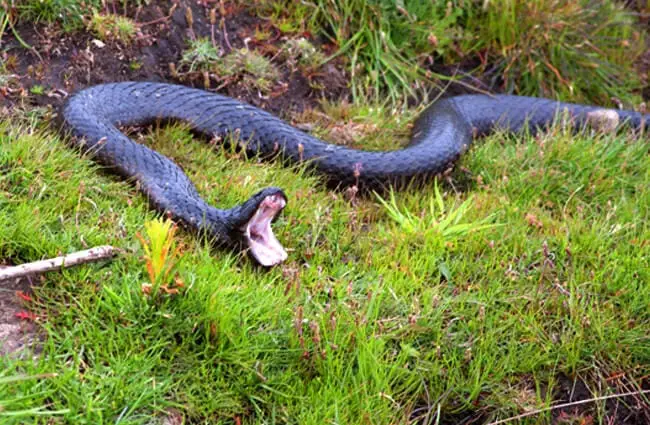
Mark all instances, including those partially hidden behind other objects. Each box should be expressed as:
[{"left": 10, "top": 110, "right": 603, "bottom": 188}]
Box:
[{"left": 136, "top": 218, "right": 182, "bottom": 298}]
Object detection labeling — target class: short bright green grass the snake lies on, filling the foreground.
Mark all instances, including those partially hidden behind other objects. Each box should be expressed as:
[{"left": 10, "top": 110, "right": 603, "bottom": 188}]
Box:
[{"left": 0, "top": 102, "right": 650, "bottom": 424}]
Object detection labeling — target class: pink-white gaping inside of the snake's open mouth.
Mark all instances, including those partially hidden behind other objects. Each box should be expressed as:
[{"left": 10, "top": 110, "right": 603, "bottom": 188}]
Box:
[{"left": 244, "top": 195, "right": 287, "bottom": 267}]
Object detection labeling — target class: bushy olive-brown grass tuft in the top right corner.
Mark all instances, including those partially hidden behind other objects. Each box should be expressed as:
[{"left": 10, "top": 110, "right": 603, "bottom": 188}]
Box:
[{"left": 461, "top": 0, "right": 645, "bottom": 105}]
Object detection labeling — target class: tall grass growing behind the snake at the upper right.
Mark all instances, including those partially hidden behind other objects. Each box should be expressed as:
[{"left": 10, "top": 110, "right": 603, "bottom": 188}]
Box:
[{"left": 247, "top": 0, "right": 645, "bottom": 103}]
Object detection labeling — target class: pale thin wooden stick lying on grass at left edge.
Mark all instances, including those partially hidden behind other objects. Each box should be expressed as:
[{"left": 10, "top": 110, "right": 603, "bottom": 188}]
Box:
[{"left": 0, "top": 245, "right": 118, "bottom": 282}]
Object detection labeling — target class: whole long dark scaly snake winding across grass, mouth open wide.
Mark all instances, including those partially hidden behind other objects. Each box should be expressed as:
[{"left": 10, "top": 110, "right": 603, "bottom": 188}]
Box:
[{"left": 62, "top": 82, "right": 650, "bottom": 267}]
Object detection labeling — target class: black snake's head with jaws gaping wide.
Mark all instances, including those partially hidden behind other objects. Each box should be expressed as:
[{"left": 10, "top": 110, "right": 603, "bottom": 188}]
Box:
[{"left": 230, "top": 187, "right": 287, "bottom": 267}]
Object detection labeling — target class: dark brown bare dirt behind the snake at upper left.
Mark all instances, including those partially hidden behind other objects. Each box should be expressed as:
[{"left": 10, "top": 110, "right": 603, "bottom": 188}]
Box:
[{"left": 0, "top": 0, "right": 348, "bottom": 116}]
